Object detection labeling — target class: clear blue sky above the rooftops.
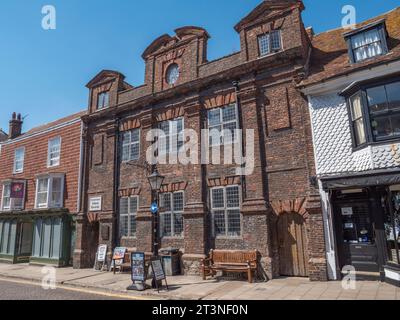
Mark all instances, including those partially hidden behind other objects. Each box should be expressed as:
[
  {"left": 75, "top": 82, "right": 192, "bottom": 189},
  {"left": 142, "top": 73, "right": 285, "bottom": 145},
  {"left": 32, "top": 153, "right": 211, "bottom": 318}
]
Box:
[{"left": 0, "top": 0, "right": 400, "bottom": 131}]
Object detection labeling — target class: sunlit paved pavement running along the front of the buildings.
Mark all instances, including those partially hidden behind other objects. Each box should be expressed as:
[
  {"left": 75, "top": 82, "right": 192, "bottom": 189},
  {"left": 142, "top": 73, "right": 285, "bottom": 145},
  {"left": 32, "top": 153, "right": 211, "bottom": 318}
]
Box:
[{"left": 0, "top": 264, "right": 400, "bottom": 300}]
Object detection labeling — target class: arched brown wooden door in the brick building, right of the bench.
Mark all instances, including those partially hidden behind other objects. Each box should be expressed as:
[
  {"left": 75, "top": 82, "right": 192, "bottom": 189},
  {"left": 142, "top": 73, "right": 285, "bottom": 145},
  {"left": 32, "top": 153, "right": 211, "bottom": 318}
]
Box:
[{"left": 278, "top": 213, "right": 308, "bottom": 277}]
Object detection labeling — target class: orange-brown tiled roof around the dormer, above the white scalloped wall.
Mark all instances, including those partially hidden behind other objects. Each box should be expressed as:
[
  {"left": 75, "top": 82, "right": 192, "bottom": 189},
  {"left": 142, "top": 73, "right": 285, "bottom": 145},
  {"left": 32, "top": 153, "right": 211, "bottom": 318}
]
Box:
[{"left": 300, "top": 7, "right": 400, "bottom": 86}]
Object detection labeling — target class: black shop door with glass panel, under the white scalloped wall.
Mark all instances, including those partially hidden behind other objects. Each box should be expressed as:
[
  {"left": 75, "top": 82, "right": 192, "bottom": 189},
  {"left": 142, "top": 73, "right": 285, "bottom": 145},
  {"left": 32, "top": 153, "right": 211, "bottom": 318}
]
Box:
[{"left": 336, "top": 200, "right": 379, "bottom": 272}]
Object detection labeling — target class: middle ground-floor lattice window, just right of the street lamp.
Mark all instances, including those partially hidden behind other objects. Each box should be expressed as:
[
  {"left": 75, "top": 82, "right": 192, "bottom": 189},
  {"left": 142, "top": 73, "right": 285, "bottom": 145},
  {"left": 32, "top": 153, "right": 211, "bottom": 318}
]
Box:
[{"left": 160, "top": 191, "right": 184, "bottom": 237}]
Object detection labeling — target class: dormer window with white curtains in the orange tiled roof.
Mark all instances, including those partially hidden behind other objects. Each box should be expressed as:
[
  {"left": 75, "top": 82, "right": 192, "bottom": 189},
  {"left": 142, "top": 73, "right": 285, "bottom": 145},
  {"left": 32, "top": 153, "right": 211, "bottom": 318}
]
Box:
[{"left": 345, "top": 22, "right": 388, "bottom": 63}]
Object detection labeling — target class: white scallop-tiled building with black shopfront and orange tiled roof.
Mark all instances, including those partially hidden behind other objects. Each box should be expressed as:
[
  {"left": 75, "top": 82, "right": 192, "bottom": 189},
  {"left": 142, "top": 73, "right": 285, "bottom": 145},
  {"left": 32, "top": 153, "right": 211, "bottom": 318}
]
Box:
[{"left": 300, "top": 8, "right": 400, "bottom": 285}]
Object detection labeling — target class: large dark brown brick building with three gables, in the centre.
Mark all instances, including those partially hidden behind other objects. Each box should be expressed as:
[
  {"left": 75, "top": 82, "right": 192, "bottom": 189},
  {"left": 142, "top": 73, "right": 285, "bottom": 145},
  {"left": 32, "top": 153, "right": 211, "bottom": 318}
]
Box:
[{"left": 74, "top": 0, "right": 327, "bottom": 280}]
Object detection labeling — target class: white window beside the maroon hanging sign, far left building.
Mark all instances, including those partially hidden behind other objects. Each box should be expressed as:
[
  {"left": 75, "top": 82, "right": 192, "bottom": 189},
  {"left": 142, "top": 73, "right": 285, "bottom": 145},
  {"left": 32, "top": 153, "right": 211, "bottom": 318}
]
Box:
[{"left": 1, "top": 181, "right": 25, "bottom": 211}]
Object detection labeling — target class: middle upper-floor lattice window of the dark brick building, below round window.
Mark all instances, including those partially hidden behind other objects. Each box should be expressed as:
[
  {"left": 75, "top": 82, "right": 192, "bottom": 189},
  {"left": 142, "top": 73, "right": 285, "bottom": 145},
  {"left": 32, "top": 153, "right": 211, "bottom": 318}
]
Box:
[{"left": 158, "top": 118, "right": 184, "bottom": 155}]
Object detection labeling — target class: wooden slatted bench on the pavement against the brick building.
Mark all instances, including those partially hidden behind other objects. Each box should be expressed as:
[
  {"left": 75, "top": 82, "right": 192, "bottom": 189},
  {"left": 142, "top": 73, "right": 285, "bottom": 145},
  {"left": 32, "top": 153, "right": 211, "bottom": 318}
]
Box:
[{"left": 201, "top": 250, "right": 258, "bottom": 283}]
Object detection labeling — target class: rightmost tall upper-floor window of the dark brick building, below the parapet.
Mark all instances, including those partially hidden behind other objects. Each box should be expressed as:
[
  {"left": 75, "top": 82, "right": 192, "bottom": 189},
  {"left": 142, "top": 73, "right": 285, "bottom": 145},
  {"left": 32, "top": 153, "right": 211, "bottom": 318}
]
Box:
[{"left": 208, "top": 104, "right": 239, "bottom": 146}]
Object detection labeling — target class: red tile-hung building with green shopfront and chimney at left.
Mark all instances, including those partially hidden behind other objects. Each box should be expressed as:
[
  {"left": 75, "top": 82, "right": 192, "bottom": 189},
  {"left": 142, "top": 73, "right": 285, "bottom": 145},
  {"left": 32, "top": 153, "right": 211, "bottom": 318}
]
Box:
[{"left": 0, "top": 112, "right": 84, "bottom": 266}]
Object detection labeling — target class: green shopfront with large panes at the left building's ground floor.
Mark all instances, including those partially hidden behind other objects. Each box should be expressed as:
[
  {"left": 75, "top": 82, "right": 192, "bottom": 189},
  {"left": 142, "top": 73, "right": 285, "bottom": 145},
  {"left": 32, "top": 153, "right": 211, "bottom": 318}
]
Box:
[{"left": 0, "top": 209, "right": 74, "bottom": 267}]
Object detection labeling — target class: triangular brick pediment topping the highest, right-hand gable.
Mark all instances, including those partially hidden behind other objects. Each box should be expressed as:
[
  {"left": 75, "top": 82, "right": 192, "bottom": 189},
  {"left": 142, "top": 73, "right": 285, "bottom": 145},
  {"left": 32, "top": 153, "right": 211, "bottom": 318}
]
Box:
[{"left": 235, "top": 0, "right": 304, "bottom": 32}]
